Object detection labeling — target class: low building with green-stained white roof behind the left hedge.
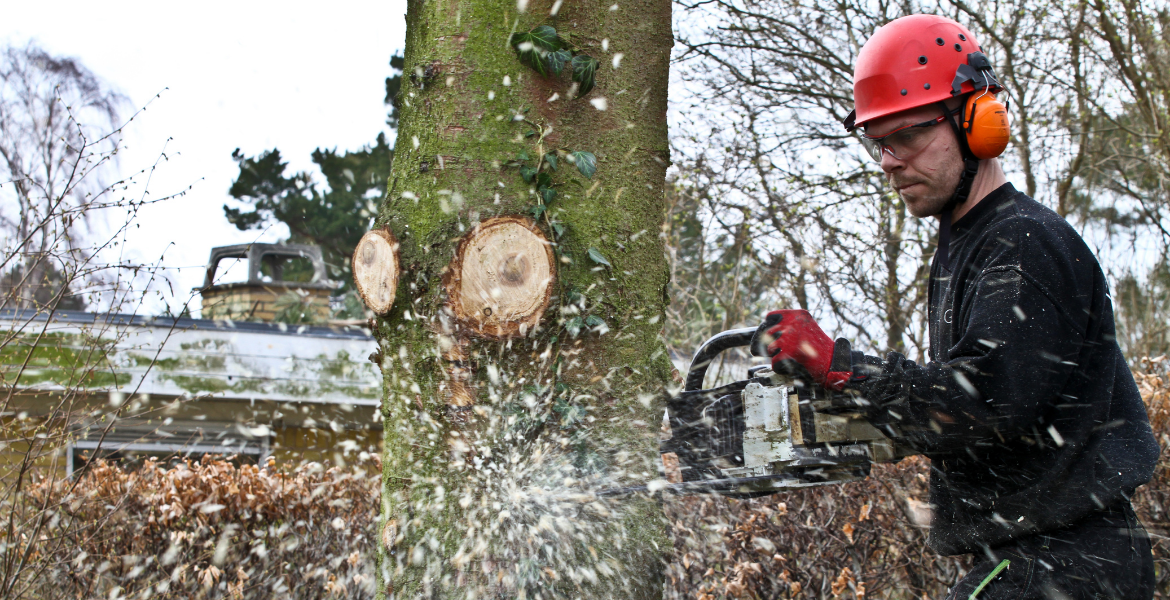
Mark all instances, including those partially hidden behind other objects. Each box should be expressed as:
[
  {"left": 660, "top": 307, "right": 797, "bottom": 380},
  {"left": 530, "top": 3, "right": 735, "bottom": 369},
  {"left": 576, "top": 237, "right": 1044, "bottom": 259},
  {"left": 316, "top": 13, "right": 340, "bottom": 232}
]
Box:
[{"left": 0, "top": 242, "right": 381, "bottom": 473}]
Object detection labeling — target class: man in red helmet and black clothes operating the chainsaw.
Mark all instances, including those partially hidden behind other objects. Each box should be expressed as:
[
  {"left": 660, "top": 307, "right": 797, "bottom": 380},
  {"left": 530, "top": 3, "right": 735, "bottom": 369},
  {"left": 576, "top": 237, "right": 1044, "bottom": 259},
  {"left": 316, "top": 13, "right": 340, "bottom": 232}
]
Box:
[{"left": 753, "top": 15, "right": 1158, "bottom": 599}]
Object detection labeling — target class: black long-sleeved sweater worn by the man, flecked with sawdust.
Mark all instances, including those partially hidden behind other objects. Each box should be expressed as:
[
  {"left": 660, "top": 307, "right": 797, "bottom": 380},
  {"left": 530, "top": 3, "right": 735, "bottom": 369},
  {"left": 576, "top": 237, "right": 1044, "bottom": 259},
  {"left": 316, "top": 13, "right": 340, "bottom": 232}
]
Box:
[{"left": 854, "top": 184, "right": 1158, "bottom": 554}]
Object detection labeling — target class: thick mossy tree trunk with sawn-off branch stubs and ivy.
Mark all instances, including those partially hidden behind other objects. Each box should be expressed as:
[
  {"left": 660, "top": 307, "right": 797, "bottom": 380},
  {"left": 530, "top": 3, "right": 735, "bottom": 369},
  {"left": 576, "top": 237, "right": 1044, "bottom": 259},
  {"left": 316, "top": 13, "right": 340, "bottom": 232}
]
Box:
[{"left": 372, "top": 0, "right": 673, "bottom": 599}]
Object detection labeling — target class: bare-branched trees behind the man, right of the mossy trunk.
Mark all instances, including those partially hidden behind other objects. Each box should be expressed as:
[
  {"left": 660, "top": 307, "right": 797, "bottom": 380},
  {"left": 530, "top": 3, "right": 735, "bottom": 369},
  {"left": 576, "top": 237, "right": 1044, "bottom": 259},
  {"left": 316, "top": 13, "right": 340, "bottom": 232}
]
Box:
[{"left": 667, "top": 0, "right": 1170, "bottom": 360}]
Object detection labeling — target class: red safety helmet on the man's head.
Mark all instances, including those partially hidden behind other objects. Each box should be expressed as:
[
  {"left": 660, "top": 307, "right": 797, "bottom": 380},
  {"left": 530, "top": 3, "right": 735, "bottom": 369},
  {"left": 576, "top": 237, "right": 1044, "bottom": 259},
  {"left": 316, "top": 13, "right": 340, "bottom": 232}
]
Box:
[{"left": 845, "top": 14, "right": 1003, "bottom": 131}]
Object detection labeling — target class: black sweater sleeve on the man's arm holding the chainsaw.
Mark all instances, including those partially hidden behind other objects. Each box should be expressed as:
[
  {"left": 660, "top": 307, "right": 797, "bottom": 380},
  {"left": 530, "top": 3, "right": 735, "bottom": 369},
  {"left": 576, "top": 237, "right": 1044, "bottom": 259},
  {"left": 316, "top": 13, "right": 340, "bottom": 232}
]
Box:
[{"left": 855, "top": 265, "right": 1085, "bottom": 455}]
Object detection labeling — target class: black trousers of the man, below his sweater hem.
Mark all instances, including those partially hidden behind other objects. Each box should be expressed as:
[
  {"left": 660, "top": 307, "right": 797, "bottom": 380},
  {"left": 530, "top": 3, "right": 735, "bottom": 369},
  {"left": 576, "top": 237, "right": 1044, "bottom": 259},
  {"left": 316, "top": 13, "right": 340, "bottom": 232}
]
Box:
[{"left": 947, "top": 501, "right": 1154, "bottom": 600}]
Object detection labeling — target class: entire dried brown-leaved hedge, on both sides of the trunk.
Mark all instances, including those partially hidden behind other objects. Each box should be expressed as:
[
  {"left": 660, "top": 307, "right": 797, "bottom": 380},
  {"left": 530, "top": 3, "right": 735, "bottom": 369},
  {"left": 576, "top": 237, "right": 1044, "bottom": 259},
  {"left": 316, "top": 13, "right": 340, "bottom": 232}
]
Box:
[{"left": 9, "top": 360, "right": 1170, "bottom": 600}]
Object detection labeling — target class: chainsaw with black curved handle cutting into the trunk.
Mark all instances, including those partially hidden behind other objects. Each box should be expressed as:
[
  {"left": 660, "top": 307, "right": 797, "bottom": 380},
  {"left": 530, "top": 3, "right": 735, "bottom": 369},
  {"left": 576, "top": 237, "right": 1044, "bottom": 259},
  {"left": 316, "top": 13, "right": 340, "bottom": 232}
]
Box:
[{"left": 598, "top": 327, "right": 914, "bottom": 498}]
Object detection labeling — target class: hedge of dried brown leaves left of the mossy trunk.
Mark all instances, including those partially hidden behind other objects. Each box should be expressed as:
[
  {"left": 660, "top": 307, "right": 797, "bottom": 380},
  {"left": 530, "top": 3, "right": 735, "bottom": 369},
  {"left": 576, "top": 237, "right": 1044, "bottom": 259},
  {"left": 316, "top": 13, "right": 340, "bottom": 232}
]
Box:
[{"left": 18, "top": 460, "right": 378, "bottom": 599}]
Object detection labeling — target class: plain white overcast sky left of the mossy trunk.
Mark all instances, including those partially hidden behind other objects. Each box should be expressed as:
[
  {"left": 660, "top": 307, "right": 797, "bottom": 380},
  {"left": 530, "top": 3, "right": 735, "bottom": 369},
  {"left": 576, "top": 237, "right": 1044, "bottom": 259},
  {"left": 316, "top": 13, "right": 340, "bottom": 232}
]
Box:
[{"left": 0, "top": 0, "right": 406, "bottom": 312}]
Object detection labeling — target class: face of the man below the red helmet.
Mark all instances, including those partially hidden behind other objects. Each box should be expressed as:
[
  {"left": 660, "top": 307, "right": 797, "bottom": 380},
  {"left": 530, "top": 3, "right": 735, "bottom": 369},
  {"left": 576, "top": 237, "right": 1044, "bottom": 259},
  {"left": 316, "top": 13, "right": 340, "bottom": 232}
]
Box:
[{"left": 866, "top": 105, "right": 963, "bottom": 218}]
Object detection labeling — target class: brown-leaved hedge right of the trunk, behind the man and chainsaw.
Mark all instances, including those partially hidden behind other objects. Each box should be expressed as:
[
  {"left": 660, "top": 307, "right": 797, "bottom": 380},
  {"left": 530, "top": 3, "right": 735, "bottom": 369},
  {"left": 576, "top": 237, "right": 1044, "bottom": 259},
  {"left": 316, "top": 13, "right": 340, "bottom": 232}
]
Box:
[{"left": 667, "top": 358, "right": 1170, "bottom": 600}]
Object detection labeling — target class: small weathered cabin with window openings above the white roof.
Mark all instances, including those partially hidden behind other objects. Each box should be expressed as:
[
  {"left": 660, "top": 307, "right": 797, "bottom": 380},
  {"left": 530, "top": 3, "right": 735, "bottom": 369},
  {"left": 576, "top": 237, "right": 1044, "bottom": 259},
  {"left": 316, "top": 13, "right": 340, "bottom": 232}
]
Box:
[{"left": 199, "top": 243, "right": 338, "bottom": 323}]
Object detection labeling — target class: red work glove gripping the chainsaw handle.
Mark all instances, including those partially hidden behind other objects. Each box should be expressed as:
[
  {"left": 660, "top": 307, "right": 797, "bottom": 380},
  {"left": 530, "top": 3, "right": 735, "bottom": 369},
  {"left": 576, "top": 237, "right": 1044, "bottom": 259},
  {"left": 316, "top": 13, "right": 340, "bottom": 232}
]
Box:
[{"left": 751, "top": 310, "right": 853, "bottom": 391}]
